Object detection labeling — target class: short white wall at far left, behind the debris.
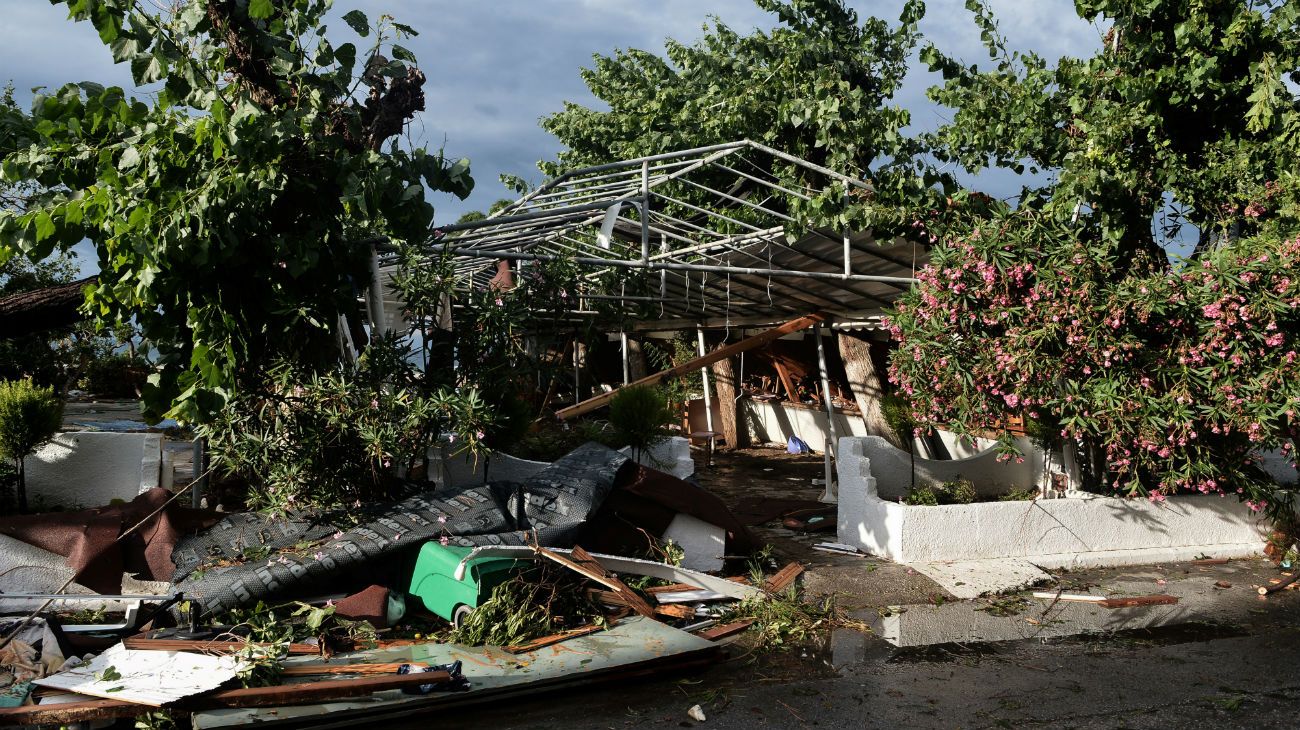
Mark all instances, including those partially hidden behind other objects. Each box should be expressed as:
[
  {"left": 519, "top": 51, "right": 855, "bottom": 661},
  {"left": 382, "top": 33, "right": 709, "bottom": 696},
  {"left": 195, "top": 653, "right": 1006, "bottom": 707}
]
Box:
[{"left": 26, "top": 431, "right": 163, "bottom": 509}]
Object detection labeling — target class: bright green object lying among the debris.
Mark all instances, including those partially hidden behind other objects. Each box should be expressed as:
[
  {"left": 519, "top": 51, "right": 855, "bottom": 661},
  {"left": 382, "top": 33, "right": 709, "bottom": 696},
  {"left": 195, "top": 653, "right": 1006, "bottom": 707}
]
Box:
[{"left": 410, "top": 540, "right": 528, "bottom": 626}]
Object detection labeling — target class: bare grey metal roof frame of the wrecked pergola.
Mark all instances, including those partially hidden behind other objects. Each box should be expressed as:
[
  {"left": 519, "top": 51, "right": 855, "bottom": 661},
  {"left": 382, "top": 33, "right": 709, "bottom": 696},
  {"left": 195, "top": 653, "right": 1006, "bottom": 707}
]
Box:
[{"left": 376, "top": 140, "right": 917, "bottom": 322}]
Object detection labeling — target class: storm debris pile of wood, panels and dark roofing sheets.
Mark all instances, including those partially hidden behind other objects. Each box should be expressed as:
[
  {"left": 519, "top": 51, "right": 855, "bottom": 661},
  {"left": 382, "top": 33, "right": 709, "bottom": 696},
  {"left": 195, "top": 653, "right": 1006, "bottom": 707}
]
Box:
[{"left": 0, "top": 444, "right": 820, "bottom": 727}]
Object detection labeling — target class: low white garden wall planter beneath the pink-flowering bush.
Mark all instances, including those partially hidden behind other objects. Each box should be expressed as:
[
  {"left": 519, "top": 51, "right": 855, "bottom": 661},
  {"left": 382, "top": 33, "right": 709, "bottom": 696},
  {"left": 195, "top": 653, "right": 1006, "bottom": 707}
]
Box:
[{"left": 839, "top": 436, "right": 1265, "bottom": 568}]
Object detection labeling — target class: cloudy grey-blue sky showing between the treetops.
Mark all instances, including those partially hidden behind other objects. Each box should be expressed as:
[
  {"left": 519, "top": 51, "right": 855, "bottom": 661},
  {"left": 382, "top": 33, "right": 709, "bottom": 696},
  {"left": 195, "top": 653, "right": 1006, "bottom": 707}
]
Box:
[{"left": 0, "top": 0, "right": 1101, "bottom": 268}]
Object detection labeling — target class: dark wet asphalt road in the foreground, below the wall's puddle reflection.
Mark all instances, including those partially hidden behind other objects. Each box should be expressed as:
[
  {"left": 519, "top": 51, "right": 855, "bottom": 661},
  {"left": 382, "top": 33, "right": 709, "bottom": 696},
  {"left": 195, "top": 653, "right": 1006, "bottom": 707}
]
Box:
[{"left": 446, "top": 569, "right": 1300, "bottom": 730}]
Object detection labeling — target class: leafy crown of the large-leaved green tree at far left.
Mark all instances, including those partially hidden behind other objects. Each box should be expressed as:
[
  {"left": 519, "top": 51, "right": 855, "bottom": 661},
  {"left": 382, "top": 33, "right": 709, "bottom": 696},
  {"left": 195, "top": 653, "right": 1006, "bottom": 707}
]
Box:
[{"left": 0, "top": 0, "right": 472, "bottom": 422}]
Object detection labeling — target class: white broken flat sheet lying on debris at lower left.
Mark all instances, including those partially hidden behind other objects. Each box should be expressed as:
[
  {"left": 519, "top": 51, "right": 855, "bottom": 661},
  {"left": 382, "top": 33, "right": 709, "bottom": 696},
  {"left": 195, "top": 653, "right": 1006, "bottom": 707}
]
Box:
[{"left": 34, "top": 644, "right": 243, "bottom": 707}]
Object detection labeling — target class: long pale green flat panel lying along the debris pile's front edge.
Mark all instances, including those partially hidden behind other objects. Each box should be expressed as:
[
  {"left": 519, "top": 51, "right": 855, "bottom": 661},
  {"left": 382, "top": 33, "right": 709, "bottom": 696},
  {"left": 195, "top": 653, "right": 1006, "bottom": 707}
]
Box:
[{"left": 194, "top": 616, "right": 716, "bottom": 730}]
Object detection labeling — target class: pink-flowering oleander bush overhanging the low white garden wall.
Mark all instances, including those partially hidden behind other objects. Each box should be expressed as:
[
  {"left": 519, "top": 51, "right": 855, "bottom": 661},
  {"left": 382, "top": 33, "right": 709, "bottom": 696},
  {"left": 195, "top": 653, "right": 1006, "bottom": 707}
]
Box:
[{"left": 887, "top": 225, "right": 1300, "bottom": 505}]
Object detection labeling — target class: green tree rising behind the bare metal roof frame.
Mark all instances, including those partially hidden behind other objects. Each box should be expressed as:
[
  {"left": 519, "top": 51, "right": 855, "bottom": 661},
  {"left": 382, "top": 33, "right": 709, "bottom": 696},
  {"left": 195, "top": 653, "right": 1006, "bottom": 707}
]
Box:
[{"left": 540, "top": 0, "right": 943, "bottom": 231}]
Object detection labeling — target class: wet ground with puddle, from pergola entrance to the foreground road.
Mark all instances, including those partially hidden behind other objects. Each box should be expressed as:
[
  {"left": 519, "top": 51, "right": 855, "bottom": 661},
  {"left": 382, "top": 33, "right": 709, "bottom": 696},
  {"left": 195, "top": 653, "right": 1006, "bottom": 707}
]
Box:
[{"left": 443, "top": 449, "right": 1300, "bottom": 730}]
